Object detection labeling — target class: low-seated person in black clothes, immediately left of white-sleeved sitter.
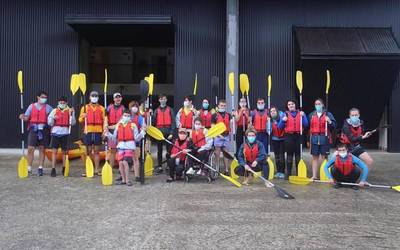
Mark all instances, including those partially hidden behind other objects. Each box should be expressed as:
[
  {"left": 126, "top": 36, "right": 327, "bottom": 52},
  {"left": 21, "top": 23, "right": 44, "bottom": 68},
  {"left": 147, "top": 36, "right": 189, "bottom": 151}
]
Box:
[{"left": 167, "top": 128, "right": 190, "bottom": 182}]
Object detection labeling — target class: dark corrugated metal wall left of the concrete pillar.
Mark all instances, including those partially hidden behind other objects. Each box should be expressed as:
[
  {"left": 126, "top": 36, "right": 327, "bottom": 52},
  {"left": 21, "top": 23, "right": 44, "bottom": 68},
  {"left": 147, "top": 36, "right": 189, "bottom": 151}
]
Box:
[{"left": 0, "top": 0, "right": 226, "bottom": 147}]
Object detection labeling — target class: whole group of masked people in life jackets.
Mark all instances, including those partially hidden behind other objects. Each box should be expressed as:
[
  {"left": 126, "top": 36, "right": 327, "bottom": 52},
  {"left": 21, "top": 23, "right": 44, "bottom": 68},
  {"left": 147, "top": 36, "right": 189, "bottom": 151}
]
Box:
[{"left": 20, "top": 91, "right": 373, "bottom": 186}]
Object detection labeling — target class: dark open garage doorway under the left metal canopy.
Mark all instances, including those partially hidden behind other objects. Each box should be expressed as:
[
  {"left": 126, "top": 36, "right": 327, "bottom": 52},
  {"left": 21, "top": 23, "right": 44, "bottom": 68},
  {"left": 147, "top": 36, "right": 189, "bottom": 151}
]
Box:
[{"left": 65, "top": 16, "right": 175, "bottom": 106}]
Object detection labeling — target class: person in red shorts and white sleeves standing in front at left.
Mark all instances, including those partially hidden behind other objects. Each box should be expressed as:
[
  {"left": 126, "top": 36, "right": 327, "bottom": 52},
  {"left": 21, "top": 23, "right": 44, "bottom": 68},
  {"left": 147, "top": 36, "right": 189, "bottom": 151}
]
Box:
[{"left": 108, "top": 110, "right": 145, "bottom": 186}]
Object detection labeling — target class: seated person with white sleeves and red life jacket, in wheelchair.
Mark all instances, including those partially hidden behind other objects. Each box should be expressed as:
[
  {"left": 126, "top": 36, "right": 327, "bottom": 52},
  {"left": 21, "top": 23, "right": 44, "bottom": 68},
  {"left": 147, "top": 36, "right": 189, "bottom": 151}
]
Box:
[{"left": 185, "top": 117, "right": 213, "bottom": 175}]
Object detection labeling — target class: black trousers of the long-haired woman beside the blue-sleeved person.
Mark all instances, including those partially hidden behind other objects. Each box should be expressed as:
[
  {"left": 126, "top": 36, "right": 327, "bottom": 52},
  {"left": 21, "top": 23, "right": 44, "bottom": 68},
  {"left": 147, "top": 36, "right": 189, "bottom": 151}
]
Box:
[{"left": 285, "top": 134, "right": 302, "bottom": 175}]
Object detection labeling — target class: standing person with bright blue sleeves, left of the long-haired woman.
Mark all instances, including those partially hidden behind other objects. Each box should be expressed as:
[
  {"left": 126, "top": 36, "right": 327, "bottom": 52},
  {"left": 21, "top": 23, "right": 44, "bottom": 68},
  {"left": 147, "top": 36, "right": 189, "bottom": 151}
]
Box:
[{"left": 268, "top": 106, "right": 285, "bottom": 179}]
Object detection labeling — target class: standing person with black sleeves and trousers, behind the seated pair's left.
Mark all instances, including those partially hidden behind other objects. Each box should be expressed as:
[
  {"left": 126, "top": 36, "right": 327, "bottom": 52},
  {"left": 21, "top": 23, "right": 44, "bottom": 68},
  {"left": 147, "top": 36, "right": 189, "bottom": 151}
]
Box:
[{"left": 152, "top": 94, "right": 175, "bottom": 174}]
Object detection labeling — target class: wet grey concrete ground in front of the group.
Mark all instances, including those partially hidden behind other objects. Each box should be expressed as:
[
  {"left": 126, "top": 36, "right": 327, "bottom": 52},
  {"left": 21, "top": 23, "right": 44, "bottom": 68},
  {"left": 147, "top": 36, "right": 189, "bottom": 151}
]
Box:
[{"left": 0, "top": 151, "right": 400, "bottom": 249}]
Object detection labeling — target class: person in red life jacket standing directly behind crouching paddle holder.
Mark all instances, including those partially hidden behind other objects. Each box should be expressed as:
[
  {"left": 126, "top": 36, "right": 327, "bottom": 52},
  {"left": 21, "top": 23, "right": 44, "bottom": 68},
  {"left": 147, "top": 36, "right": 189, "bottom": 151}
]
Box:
[{"left": 251, "top": 98, "right": 269, "bottom": 148}]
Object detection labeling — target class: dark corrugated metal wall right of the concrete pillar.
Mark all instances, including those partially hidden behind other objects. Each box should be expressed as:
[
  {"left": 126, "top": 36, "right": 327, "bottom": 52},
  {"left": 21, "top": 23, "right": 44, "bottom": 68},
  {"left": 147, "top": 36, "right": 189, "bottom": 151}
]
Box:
[{"left": 239, "top": 0, "right": 400, "bottom": 151}]
